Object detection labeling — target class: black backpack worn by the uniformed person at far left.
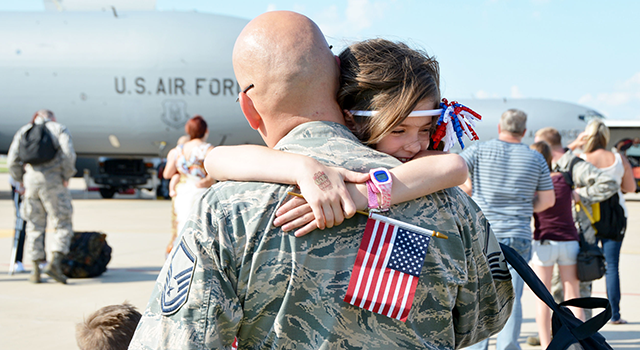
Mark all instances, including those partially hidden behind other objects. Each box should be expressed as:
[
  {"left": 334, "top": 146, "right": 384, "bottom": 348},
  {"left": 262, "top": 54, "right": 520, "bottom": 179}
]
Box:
[{"left": 18, "top": 122, "right": 58, "bottom": 165}]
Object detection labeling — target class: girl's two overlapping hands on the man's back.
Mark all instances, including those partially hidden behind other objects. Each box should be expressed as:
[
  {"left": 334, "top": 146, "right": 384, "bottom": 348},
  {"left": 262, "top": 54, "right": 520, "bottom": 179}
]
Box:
[{"left": 274, "top": 162, "right": 369, "bottom": 236}]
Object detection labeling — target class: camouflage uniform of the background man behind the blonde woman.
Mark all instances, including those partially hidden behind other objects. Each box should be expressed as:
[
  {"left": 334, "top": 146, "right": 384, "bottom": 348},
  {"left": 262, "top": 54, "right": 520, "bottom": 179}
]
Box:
[{"left": 551, "top": 150, "right": 620, "bottom": 319}]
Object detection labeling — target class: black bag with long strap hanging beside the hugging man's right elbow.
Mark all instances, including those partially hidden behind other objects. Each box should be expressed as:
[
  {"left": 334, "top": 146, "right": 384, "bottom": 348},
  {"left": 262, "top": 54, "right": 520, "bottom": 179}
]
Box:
[{"left": 500, "top": 243, "right": 613, "bottom": 350}]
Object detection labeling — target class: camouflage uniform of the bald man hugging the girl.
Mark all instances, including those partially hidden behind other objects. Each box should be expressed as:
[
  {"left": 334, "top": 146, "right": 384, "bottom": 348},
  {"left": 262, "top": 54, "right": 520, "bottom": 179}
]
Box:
[{"left": 129, "top": 122, "right": 513, "bottom": 349}]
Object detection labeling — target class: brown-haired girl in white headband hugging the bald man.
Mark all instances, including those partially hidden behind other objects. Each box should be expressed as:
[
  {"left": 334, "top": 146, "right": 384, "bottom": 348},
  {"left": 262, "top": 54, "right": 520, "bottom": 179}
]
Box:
[{"left": 205, "top": 39, "right": 480, "bottom": 236}]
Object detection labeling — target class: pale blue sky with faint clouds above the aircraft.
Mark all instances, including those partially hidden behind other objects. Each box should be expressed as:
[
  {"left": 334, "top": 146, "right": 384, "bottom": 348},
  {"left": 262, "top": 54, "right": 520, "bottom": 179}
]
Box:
[{"left": 0, "top": 0, "right": 640, "bottom": 120}]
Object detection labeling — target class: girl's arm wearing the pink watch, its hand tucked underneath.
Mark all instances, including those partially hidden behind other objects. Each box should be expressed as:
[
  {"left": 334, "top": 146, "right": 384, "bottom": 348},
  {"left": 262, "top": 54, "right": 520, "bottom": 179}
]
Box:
[{"left": 273, "top": 151, "right": 468, "bottom": 236}]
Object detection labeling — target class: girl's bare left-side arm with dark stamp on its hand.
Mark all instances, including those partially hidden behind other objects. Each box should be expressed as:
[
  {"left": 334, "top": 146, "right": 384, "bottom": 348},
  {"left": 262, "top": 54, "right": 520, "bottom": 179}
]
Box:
[{"left": 204, "top": 145, "right": 369, "bottom": 229}]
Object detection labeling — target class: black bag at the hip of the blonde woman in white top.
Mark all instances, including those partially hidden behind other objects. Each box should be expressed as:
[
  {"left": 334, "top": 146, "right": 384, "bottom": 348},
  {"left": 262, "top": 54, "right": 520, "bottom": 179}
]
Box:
[{"left": 591, "top": 193, "right": 627, "bottom": 242}]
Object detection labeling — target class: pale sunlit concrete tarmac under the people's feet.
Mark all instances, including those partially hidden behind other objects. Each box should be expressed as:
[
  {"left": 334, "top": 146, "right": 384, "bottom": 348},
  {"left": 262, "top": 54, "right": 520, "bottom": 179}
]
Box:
[{"left": 0, "top": 174, "right": 640, "bottom": 350}]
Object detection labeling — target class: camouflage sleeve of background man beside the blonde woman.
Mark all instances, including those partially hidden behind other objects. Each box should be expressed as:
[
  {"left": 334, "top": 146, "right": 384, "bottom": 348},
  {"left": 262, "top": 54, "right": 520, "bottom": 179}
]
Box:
[{"left": 572, "top": 161, "right": 620, "bottom": 203}]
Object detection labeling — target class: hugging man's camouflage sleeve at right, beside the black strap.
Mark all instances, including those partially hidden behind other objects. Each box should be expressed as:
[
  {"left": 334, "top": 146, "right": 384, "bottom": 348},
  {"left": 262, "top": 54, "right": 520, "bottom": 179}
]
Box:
[{"left": 452, "top": 191, "right": 514, "bottom": 349}]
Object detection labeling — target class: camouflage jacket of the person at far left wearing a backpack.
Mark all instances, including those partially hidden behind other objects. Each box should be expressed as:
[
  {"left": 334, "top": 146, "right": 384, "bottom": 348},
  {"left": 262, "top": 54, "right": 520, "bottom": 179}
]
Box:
[{"left": 7, "top": 117, "right": 76, "bottom": 183}]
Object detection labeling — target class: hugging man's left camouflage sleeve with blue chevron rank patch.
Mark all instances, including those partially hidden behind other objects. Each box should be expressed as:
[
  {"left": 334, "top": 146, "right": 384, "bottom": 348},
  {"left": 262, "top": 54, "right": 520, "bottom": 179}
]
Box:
[{"left": 129, "top": 189, "right": 243, "bottom": 350}]
